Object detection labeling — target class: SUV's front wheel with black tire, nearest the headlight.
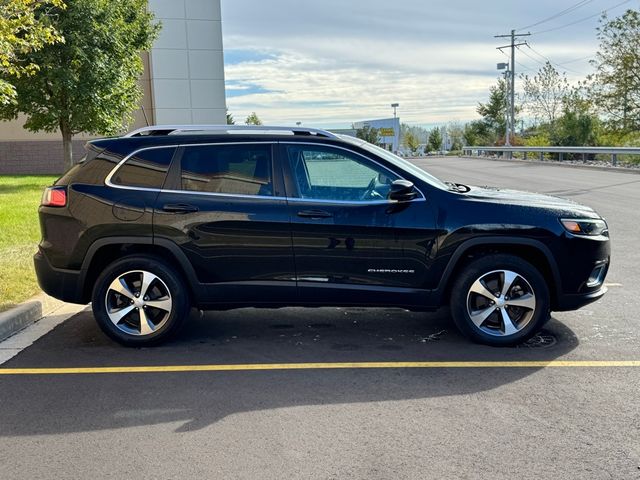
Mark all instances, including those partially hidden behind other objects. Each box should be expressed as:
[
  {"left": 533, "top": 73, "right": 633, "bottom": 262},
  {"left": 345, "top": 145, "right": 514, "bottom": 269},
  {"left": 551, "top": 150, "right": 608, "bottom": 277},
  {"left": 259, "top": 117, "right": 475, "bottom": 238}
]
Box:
[{"left": 451, "top": 254, "right": 550, "bottom": 347}]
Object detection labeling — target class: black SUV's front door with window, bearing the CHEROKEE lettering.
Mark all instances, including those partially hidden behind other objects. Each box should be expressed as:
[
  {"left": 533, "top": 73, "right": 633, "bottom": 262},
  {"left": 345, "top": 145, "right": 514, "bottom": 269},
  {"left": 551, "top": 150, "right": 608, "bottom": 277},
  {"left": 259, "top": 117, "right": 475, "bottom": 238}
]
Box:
[{"left": 281, "top": 142, "right": 424, "bottom": 305}]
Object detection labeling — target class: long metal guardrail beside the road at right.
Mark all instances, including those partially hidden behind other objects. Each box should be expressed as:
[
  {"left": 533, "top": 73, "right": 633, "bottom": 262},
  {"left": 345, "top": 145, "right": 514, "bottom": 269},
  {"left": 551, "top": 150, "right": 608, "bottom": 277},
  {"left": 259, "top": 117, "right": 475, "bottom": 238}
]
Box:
[{"left": 462, "top": 146, "right": 640, "bottom": 165}]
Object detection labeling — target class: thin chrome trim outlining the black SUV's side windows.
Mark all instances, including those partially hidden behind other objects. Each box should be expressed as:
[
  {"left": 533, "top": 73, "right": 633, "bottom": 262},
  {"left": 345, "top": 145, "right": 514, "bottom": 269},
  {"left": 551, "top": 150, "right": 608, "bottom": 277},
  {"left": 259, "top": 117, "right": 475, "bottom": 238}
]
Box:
[{"left": 104, "top": 140, "right": 426, "bottom": 205}]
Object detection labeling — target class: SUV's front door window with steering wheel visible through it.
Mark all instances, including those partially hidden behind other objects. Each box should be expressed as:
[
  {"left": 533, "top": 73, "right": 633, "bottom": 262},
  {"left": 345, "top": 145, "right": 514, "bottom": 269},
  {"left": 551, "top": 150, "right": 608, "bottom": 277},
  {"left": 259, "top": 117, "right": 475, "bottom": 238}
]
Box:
[{"left": 287, "top": 145, "right": 399, "bottom": 201}]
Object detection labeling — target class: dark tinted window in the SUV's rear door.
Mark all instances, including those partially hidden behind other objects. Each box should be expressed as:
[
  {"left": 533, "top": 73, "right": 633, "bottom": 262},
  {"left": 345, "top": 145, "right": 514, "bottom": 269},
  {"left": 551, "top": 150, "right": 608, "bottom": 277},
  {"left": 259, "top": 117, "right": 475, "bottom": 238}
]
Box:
[{"left": 181, "top": 144, "right": 273, "bottom": 196}]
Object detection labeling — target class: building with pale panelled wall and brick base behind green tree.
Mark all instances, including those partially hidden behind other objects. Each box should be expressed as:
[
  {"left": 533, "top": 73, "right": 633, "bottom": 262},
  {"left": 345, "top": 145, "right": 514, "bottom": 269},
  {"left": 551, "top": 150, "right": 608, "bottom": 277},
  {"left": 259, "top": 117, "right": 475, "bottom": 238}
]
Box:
[{"left": 0, "top": 0, "right": 226, "bottom": 174}]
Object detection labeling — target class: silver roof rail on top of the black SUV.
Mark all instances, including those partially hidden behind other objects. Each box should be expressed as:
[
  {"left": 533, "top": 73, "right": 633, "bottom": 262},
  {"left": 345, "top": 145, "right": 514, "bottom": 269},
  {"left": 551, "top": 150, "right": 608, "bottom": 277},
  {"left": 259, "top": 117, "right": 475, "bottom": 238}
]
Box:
[{"left": 124, "top": 125, "right": 339, "bottom": 139}]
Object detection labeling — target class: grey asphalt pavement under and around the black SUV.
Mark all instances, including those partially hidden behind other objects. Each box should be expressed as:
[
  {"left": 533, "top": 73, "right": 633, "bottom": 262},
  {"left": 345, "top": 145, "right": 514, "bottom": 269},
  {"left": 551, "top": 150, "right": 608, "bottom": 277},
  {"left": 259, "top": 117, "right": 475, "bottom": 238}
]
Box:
[{"left": 0, "top": 158, "right": 640, "bottom": 479}]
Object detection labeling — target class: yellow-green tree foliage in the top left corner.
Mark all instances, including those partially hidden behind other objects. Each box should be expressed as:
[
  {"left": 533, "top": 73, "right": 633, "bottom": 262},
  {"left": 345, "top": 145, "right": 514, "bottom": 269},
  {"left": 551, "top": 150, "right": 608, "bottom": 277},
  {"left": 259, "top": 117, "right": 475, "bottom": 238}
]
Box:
[{"left": 0, "top": 0, "right": 64, "bottom": 105}]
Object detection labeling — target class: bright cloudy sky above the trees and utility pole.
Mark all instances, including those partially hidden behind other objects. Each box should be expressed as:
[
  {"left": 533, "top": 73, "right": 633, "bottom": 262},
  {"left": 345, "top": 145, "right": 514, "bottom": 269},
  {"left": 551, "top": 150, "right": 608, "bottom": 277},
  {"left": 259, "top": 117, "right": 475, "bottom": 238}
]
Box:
[{"left": 221, "top": 0, "right": 640, "bottom": 128}]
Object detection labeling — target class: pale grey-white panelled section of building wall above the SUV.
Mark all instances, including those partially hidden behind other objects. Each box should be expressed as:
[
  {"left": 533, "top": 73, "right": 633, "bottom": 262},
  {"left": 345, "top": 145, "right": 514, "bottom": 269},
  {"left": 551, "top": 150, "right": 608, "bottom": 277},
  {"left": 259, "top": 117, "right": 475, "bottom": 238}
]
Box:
[{"left": 149, "top": 0, "right": 226, "bottom": 124}]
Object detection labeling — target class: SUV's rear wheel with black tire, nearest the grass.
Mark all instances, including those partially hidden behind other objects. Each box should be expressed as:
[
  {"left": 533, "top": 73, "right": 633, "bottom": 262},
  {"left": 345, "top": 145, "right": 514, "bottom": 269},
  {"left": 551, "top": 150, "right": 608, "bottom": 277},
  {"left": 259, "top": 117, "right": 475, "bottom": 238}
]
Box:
[{"left": 92, "top": 255, "right": 190, "bottom": 347}]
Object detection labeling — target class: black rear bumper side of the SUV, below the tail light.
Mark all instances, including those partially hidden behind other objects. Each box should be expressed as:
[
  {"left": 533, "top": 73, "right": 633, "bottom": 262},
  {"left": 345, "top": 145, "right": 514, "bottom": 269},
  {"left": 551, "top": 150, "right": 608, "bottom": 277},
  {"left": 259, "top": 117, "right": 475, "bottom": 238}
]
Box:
[{"left": 33, "top": 252, "right": 87, "bottom": 305}]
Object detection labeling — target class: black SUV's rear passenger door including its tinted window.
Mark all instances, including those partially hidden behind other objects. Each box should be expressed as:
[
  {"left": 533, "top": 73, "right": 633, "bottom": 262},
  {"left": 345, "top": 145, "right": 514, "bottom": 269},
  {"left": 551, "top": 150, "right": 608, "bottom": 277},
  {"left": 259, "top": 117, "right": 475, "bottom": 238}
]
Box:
[{"left": 154, "top": 142, "right": 296, "bottom": 304}]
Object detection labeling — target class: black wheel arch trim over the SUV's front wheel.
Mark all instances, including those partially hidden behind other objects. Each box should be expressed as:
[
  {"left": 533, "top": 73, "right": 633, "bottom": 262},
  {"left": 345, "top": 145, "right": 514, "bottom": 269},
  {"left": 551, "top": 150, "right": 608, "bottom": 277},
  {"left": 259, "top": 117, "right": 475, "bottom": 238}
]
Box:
[{"left": 438, "top": 237, "right": 562, "bottom": 307}]
